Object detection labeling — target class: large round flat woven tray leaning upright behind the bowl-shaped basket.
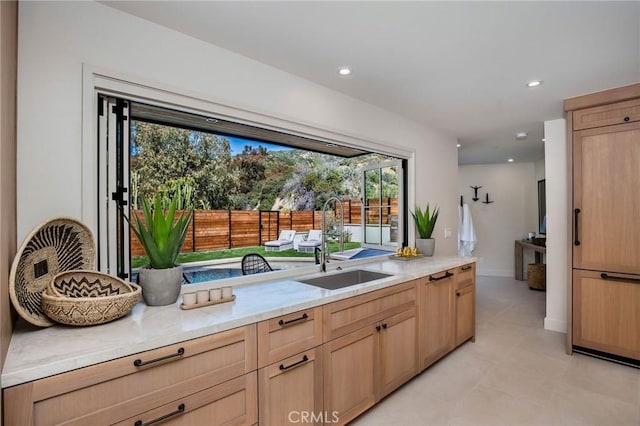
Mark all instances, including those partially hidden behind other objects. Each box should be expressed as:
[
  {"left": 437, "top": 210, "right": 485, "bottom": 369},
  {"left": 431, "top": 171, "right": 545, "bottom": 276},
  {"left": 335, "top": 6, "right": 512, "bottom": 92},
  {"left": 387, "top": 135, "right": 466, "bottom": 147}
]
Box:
[{"left": 9, "top": 217, "right": 96, "bottom": 327}]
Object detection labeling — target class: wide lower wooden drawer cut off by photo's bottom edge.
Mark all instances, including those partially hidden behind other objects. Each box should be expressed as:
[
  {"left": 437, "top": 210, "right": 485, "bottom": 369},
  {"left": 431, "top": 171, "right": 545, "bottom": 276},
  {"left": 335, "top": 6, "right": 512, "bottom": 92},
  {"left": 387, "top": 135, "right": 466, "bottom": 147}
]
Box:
[{"left": 117, "top": 371, "right": 258, "bottom": 426}]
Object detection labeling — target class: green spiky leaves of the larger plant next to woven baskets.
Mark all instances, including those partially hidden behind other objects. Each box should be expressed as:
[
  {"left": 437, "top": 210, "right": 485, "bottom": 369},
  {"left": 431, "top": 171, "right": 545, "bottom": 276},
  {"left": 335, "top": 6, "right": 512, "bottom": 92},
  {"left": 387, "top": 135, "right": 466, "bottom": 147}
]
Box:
[{"left": 129, "top": 195, "right": 193, "bottom": 269}]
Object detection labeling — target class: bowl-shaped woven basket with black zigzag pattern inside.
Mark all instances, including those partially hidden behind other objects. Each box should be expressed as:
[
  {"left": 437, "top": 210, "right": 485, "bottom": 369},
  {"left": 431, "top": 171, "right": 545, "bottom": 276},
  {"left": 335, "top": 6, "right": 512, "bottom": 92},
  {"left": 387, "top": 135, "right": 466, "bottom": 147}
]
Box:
[{"left": 42, "top": 270, "right": 141, "bottom": 325}]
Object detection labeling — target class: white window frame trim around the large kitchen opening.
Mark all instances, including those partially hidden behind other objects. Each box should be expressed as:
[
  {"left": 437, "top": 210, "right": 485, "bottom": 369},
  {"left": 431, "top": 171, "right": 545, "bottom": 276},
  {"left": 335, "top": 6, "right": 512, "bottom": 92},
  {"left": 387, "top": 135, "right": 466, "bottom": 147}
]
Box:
[{"left": 81, "top": 64, "right": 415, "bottom": 272}]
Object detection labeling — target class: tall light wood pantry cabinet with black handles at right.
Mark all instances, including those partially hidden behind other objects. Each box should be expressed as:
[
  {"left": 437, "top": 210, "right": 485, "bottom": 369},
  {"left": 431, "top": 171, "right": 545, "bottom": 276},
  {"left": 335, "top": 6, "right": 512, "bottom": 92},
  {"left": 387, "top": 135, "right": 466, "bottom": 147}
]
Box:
[{"left": 565, "top": 84, "right": 640, "bottom": 362}]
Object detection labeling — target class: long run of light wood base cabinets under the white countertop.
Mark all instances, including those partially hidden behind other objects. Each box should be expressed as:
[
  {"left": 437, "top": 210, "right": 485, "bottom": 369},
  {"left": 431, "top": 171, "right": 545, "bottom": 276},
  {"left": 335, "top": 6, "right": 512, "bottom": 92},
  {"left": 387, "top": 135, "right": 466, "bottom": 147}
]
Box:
[{"left": 3, "top": 264, "right": 475, "bottom": 426}]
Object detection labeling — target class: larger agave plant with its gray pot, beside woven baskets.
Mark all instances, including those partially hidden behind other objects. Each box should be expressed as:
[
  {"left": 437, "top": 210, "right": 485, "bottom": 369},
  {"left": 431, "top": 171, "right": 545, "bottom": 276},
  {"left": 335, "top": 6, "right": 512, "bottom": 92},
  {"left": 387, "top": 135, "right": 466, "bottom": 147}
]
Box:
[{"left": 130, "top": 195, "right": 192, "bottom": 306}]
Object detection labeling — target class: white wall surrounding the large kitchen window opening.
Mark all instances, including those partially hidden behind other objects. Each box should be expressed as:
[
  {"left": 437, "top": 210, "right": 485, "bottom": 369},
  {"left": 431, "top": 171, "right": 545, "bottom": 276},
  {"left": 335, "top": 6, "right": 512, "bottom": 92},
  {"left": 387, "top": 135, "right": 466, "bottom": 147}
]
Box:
[{"left": 17, "top": 2, "right": 457, "bottom": 255}]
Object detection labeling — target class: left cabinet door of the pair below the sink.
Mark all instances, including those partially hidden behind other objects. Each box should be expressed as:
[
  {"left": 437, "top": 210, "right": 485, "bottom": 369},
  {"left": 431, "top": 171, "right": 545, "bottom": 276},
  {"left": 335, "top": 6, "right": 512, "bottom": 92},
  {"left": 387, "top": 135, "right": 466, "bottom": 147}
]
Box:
[{"left": 322, "top": 325, "right": 379, "bottom": 425}]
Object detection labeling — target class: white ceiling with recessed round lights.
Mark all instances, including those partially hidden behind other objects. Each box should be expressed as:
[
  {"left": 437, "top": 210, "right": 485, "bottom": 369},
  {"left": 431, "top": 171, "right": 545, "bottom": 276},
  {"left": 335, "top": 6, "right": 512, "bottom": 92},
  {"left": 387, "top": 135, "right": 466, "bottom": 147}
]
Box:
[{"left": 103, "top": 1, "right": 640, "bottom": 164}]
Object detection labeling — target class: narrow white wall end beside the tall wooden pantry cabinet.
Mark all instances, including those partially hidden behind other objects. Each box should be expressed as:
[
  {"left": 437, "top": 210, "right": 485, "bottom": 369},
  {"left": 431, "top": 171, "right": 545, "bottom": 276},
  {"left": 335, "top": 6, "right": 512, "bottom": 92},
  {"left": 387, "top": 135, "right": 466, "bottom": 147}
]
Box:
[{"left": 544, "top": 119, "right": 570, "bottom": 332}]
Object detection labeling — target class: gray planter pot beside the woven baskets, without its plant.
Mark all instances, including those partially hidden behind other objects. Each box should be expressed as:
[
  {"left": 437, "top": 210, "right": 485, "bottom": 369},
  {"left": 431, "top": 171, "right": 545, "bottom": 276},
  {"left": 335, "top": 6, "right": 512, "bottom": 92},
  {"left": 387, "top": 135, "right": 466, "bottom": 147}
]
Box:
[{"left": 138, "top": 265, "right": 182, "bottom": 306}]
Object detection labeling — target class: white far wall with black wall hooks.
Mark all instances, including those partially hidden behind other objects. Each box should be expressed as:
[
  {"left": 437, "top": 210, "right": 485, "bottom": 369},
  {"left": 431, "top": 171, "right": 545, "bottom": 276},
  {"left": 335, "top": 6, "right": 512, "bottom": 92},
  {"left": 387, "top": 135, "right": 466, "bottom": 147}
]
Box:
[{"left": 458, "top": 163, "right": 538, "bottom": 277}]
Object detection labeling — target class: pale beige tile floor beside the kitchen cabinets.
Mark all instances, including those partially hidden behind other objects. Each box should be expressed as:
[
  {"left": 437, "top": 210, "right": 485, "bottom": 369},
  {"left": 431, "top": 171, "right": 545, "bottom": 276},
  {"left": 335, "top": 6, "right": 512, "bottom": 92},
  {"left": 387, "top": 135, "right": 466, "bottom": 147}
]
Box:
[{"left": 352, "top": 276, "right": 640, "bottom": 426}]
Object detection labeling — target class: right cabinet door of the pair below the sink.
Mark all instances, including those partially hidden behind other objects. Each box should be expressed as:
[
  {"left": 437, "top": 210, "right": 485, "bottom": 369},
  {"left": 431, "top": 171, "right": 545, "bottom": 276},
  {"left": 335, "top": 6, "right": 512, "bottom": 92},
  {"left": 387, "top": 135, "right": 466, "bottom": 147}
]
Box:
[{"left": 379, "top": 308, "right": 418, "bottom": 398}]
